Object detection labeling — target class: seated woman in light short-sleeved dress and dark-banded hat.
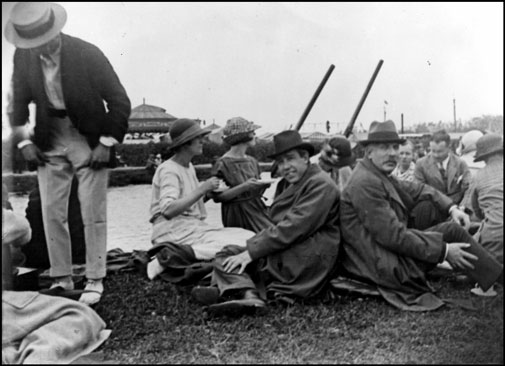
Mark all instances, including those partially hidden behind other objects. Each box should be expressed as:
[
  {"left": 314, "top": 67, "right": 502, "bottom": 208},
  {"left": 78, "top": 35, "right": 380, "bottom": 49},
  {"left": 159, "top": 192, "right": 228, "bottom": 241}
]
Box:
[{"left": 147, "top": 118, "right": 254, "bottom": 280}]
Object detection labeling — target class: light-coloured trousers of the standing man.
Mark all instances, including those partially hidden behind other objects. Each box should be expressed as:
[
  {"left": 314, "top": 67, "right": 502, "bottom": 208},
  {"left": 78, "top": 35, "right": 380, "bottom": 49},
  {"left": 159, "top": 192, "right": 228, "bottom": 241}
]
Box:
[{"left": 37, "top": 117, "right": 108, "bottom": 279}]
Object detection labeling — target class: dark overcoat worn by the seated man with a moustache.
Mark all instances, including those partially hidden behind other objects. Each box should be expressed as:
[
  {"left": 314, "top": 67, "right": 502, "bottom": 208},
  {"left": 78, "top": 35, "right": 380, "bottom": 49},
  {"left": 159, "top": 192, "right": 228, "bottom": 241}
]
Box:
[{"left": 340, "top": 158, "right": 452, "bottom": 310}]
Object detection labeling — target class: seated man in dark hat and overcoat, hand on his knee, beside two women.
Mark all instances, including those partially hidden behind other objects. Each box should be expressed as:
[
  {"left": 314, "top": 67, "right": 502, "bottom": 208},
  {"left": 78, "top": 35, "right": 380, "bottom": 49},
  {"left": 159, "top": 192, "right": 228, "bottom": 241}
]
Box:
[{"left": 192, "top": 131, "right": 340, "bottom": 315}]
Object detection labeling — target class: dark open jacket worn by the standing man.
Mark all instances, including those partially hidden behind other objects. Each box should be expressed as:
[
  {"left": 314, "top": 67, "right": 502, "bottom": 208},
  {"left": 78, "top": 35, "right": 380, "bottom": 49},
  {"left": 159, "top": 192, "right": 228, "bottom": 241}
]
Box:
[{"left": 11, "top": 33, "right": 131, "bottom": 155}]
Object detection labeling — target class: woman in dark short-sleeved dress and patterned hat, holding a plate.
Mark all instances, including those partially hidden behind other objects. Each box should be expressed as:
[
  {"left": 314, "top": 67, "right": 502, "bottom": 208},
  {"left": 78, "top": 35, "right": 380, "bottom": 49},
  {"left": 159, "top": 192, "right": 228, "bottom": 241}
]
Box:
[{"left": 212, "top": 117, "right": 271, "bottom": 233}]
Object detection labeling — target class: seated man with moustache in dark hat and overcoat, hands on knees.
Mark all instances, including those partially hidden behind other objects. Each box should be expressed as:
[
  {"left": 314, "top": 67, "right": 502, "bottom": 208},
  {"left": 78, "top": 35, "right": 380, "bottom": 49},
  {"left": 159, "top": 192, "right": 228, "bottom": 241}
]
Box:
[{"left": 340, "top": 121, "right": 503, "bottom": 311}]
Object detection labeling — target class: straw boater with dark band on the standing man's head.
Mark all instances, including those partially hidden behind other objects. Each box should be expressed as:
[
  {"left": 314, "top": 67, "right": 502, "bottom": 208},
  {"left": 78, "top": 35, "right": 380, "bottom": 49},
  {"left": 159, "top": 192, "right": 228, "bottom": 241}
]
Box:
[{"left": 4, "top": 2, "right": 67, "bottom": 48}]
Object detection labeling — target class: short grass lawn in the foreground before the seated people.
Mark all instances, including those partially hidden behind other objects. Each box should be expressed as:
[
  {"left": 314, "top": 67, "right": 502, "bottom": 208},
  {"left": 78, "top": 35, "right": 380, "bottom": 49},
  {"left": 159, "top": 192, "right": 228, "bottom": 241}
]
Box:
[{"left": 95, "top": 272, "right": 503, "bottom": 364}]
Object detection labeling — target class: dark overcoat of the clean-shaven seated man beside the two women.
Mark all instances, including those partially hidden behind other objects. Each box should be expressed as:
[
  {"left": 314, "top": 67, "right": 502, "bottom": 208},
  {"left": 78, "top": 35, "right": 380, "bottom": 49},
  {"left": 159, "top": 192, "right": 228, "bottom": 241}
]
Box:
[{"left": 247, "top": 164, "right": 340, "bottom": 298}]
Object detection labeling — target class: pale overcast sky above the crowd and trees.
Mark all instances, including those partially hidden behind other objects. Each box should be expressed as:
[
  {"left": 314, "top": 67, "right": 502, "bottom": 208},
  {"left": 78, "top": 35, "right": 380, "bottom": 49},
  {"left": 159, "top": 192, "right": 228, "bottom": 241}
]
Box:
[{"left": 2, "top": 2, "right": 504, "bottom": 134}]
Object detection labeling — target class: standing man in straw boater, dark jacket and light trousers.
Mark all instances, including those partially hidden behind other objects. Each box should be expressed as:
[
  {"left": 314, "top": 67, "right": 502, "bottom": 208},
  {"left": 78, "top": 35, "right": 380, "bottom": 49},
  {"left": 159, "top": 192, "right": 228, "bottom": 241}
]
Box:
[{"left": 5, "top": 2, "right": 131, "bottom": 305}]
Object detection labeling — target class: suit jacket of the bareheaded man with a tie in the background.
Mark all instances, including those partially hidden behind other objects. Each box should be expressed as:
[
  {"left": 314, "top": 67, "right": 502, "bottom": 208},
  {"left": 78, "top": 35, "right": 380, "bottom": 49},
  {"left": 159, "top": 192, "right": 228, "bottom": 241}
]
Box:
[{"left": 414, "top": 153, "right": 472, "bottom": 204}]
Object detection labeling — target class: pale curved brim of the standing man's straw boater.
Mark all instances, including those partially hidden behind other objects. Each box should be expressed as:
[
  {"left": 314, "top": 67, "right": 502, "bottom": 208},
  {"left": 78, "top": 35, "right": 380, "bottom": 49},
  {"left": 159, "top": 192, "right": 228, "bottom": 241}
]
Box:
[{"left": 4, "top": 3, "right": 67, "bottom": 49}]
